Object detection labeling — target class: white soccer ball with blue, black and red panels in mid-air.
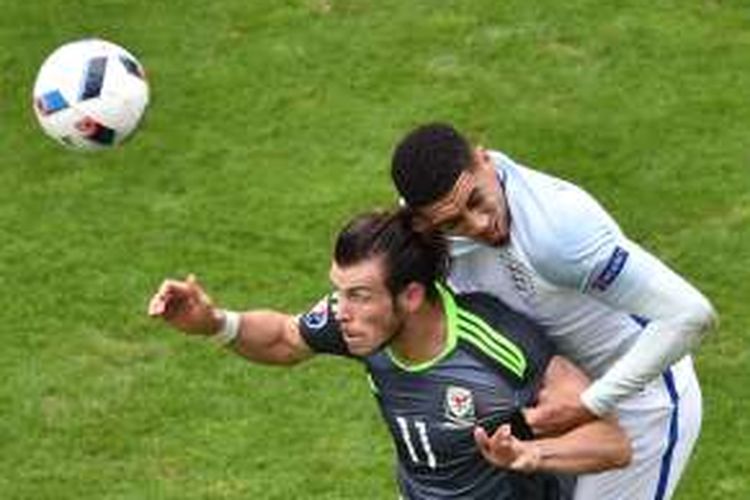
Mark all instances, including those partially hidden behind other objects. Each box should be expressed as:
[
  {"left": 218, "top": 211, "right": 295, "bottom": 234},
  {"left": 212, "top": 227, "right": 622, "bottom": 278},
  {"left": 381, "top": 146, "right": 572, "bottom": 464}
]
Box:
[{"left": 33, "top": 39, "right": 149, "bottom": 149}]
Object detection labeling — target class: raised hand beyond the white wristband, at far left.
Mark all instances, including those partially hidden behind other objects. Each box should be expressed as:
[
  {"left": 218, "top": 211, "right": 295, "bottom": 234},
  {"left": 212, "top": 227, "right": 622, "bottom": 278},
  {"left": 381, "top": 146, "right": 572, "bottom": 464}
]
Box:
[{"left": 148, "top": 274, "right": 221, "bottom": 335}]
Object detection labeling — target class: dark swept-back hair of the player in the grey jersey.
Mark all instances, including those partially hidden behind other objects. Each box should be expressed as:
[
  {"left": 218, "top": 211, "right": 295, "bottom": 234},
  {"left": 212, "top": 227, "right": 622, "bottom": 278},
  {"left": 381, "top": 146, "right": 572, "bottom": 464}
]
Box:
[{"left": 333, "top": 209, "right": 448, "bottom": 300}]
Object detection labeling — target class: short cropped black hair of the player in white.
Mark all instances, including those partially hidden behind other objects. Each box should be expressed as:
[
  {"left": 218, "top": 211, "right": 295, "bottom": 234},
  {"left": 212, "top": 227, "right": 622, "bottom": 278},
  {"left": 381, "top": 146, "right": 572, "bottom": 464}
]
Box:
[{"left": 391, "top": 123, "right": 471, "bottom": 208}]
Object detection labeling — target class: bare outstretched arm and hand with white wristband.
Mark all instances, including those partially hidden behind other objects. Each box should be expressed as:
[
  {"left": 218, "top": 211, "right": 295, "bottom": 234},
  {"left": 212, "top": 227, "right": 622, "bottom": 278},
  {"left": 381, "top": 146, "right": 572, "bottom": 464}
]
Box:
[{"left": 148, "top": 275, "right": 312, "bottom": 365}]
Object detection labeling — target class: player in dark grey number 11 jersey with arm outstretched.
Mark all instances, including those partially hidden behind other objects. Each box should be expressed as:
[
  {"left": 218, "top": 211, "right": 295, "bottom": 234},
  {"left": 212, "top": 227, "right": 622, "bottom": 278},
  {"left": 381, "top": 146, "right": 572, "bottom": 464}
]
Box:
[{"left": 149, "top": 212, "right": 631, "bottom": 500}]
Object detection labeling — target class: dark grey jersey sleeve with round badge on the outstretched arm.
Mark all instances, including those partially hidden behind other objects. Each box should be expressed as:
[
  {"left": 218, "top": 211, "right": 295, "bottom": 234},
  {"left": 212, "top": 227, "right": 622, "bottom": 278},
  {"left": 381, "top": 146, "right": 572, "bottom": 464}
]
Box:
[{"left": 297, "top": 293, "right": 352, "bottom": 357}]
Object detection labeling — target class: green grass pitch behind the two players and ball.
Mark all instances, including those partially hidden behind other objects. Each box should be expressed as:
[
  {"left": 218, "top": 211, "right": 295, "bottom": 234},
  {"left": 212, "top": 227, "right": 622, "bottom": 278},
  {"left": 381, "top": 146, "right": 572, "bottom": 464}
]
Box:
[{"left": 0, "top": 0, "right": 750, "bottom": 500}]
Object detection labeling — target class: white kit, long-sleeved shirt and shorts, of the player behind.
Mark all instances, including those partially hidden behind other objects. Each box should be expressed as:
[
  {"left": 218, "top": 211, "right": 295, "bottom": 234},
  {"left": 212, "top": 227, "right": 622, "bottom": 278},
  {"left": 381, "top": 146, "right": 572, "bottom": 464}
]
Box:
[{"left": 449, "top": 152, "right": 716, "bottom": 500}]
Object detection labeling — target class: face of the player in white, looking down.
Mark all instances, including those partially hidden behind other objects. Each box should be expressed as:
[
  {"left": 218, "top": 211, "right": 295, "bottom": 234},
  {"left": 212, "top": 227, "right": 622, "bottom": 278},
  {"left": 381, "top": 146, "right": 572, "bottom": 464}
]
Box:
[{"left": 419, "top": 149, "right": 509, "bottom": 246}]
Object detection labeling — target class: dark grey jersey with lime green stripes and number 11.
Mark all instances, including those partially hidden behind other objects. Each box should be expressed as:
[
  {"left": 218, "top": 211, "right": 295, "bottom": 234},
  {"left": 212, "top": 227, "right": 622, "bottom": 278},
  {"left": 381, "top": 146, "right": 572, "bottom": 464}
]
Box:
[{"left": 300, "top": 290, "right": 570, "bottom": 500}]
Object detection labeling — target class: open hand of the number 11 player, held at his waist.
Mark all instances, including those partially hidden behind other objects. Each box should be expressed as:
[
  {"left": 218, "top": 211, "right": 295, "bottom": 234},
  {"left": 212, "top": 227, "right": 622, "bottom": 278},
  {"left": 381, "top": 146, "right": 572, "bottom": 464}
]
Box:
[{"left": 474, "top": 424, "right": 541, "bottom": 473}]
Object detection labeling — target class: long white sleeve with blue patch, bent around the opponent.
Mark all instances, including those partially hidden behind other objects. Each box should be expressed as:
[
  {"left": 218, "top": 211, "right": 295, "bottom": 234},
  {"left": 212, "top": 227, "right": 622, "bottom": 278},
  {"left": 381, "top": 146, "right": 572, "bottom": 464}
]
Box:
[{"left": 535, "top": 184, "right": 716, "bottom": 415}]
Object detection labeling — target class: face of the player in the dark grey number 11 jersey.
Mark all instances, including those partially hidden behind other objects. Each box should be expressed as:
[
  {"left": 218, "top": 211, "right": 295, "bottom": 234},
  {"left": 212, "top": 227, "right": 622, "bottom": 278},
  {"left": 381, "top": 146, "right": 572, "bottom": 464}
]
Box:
[{"left": 330, "top": 258, "right": 403, "bottom": 356}]
